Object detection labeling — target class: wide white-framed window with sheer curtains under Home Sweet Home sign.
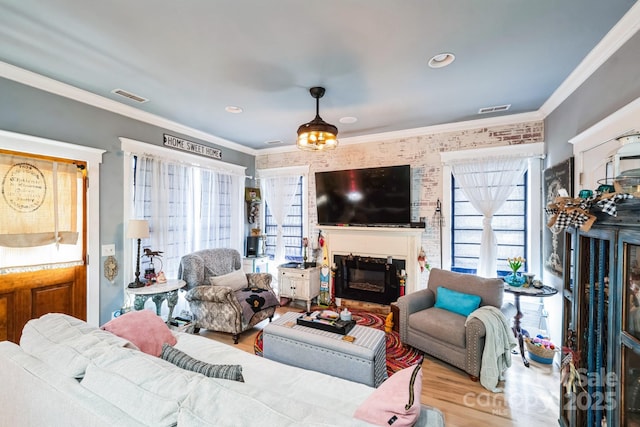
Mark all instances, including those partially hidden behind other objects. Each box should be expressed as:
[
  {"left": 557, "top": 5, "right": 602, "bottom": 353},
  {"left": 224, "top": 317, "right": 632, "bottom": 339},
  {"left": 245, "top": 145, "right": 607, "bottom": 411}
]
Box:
[{"left": 122, "top": 138, "right": 245, "bottom": 279}]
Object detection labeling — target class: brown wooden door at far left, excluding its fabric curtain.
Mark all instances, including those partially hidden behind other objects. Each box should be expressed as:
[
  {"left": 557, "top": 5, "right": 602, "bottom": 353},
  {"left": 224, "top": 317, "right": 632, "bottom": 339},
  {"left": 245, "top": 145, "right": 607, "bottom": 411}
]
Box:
[{"left": 0, "top": 150, "right": 87, "bottom": 343}]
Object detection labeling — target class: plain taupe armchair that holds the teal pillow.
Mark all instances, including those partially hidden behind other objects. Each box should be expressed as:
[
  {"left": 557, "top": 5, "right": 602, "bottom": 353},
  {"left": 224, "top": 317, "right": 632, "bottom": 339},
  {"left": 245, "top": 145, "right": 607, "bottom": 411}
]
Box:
[{"left": 397, "top": 268, "right": 516, "bottom": 381}]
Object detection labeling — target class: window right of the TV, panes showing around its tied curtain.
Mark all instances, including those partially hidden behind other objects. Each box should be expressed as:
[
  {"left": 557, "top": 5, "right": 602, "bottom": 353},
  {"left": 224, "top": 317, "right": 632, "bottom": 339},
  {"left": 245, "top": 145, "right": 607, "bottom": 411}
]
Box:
[{"left": 451, "top": 173, "right": 529, "bottom": 276}]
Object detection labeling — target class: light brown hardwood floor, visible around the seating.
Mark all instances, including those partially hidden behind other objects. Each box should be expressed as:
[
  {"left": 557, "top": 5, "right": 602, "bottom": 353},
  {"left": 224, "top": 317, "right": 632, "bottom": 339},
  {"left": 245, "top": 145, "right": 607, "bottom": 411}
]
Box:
[{"left": 200, "top": 307, "right": 560, "bottom": 427}]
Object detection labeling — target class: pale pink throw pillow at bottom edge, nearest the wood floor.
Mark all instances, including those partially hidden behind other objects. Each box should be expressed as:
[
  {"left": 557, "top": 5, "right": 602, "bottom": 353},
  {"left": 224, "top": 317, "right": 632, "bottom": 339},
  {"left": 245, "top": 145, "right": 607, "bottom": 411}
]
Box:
[{"left": 353, "top": 363, "right": 422, "bottom": 427}]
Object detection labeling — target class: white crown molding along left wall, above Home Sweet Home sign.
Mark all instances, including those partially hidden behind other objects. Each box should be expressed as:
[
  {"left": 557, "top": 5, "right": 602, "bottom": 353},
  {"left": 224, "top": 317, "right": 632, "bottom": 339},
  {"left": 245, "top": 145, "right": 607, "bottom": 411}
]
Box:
[{"left": 0, "top": 61, "right": 256, "bottom": 156}]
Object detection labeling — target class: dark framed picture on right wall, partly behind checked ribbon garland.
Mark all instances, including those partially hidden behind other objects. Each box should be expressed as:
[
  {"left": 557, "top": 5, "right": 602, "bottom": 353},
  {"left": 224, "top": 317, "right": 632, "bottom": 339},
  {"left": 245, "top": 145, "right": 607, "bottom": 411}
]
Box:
[{"left": 542, "top": 157, "right": 574, "bottom": 277}]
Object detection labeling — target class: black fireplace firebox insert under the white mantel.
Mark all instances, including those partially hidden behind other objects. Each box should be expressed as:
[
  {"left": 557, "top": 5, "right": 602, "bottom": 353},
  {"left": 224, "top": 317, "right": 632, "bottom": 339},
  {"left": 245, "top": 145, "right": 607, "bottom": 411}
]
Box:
[{"left": 333, "top": 255, "right": 405, "bottom": 304}]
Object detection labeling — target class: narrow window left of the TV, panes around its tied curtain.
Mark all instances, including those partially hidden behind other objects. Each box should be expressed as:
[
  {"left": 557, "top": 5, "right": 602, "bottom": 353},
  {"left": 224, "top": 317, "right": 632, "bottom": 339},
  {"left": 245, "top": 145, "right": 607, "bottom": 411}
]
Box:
[{"left": 264, "top": 176, "right": 304, "bottom": 262}]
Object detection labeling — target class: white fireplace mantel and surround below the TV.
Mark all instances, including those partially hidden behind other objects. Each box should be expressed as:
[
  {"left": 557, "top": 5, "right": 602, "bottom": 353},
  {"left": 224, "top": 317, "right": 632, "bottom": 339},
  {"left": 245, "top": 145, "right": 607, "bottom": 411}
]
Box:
[{"left": 318, "top": 226, "right": 424, "bottom": 293}]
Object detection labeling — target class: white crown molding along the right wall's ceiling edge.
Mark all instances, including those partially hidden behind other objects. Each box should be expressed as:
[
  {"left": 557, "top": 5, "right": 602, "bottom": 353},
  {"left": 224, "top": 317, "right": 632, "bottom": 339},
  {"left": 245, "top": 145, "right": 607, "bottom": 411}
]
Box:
[{"left": 538, "top": 2, "right": 640, "bottom": 117}]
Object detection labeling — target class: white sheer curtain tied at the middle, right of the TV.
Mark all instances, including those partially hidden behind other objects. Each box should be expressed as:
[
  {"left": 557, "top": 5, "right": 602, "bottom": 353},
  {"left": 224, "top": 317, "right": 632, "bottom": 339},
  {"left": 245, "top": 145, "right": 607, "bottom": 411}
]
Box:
[{"left": 451, "top": 157, "right": 527, "bottom": 277}]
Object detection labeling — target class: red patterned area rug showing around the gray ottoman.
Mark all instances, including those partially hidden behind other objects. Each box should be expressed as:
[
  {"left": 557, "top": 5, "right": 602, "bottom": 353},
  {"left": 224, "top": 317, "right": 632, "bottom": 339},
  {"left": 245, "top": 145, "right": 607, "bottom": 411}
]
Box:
[{"left": 253, "top": 310, "right": 423, "bottom": 376}]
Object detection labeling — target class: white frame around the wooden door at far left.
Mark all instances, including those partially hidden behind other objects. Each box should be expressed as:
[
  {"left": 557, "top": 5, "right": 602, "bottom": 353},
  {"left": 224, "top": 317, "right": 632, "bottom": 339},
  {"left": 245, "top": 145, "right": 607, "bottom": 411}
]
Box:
[{"left": 0, "top": 130, "right": 106, "bottom": 326}]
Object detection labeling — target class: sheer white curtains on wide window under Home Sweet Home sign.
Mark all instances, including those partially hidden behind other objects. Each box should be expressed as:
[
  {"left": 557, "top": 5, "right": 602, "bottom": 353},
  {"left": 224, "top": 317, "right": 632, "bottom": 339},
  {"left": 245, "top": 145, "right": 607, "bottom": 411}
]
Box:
[{"left": 132, "top": 155, "right": 244, "bottom": 278}]
